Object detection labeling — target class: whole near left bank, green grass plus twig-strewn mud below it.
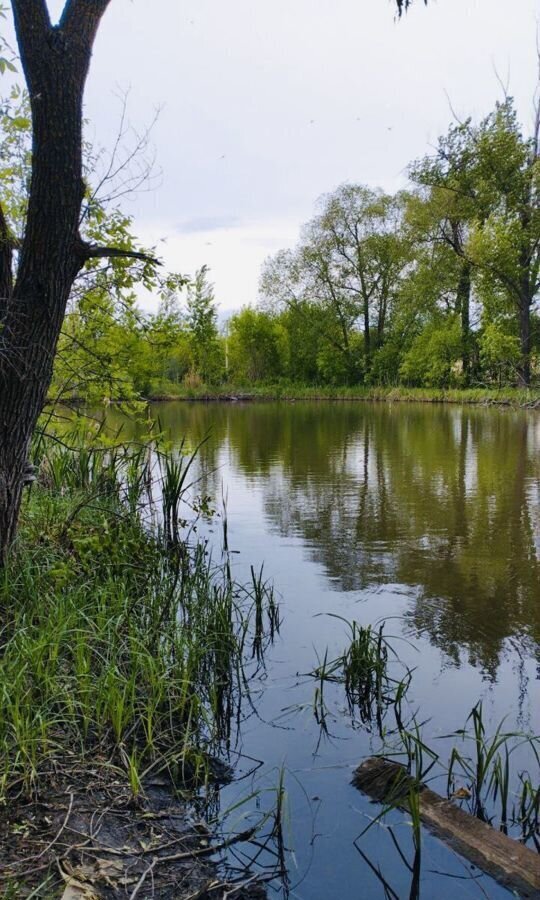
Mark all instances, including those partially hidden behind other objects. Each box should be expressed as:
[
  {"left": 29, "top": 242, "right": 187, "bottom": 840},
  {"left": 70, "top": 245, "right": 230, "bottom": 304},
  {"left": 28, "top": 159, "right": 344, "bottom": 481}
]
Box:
[{"left": 0, "top": 434, "right": 279, "bottom": 898}]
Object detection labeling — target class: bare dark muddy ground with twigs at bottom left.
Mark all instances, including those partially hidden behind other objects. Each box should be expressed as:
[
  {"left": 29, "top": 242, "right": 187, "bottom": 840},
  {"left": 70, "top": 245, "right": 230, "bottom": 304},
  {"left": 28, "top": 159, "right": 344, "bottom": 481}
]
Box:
[{"left": 0, "top": 767, "right": 267, "bottom": 900}]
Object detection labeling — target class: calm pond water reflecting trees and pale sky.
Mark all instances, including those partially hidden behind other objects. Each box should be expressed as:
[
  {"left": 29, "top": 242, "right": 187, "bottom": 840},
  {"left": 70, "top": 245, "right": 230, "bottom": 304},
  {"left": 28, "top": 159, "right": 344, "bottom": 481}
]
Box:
[{"left": 118, "top": 403, "right": 540, "bottom": 900}]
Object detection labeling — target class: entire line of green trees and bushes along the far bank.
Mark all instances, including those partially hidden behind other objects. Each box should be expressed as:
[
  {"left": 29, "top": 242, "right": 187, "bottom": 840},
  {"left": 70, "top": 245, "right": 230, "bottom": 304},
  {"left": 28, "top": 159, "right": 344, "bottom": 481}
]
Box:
[{"left": 0, "top": 89, "right": 540, "bottom": 399}]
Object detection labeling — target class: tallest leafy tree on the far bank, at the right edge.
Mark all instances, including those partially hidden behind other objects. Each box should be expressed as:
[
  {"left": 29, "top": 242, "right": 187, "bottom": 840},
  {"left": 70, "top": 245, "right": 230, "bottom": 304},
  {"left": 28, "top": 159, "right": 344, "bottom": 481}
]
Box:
[{"left": 413, "top": 98, "right": 540, "bottom": 384}]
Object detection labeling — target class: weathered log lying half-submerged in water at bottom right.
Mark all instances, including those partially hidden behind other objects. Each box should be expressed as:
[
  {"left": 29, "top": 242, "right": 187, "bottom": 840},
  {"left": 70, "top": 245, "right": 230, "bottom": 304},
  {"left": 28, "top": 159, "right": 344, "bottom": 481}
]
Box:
[{"left": 353, "top": 757, "right": 540, "bottom": 900}]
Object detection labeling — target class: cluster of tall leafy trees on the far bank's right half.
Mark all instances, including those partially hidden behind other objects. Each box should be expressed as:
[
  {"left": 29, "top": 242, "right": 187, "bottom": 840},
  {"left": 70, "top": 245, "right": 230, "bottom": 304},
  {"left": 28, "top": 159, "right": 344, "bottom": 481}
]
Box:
[{"left": 259, "top": 99, "right": 540, "bottom": 387}]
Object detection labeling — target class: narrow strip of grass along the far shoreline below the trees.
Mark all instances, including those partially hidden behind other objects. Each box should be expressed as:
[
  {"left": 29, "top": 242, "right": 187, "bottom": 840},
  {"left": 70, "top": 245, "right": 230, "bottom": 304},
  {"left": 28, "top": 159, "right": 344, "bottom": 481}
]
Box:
[{"left": 148, "top": 384, "right": 540, "bottom": 408}]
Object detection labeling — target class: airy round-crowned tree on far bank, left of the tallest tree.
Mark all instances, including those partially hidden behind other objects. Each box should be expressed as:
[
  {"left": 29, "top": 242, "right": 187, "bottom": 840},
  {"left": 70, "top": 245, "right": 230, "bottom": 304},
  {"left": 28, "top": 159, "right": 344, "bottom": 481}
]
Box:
[{"left": 261, "top": 185, "right": 411, "bottom": 383}]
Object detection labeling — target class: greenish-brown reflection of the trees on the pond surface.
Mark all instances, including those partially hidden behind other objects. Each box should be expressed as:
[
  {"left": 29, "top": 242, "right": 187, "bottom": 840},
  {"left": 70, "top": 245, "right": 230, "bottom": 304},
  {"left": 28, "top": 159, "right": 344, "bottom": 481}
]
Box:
[{"left": 110, "top": 403, "right": 540, "bottom": 678}]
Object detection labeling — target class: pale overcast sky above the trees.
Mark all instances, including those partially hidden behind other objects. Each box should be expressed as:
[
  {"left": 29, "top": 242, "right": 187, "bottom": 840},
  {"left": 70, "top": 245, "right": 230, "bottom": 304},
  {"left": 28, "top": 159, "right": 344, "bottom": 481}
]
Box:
[{"left": 15, "top": 0, "right": 540, "bottom": 309}]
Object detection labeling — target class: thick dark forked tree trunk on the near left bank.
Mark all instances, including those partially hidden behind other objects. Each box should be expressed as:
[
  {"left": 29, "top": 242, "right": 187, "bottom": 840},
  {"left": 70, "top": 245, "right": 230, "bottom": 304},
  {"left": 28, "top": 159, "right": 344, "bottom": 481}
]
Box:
[{"left": 0, "top": 0, "right": 110, "bottom": 561}]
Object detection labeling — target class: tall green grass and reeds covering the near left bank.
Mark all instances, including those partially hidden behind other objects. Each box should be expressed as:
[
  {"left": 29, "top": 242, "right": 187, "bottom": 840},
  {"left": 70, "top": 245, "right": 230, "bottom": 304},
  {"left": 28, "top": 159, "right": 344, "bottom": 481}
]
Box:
[{"left": 0, "top": 438, "right": 279, "bottom": 801}]
